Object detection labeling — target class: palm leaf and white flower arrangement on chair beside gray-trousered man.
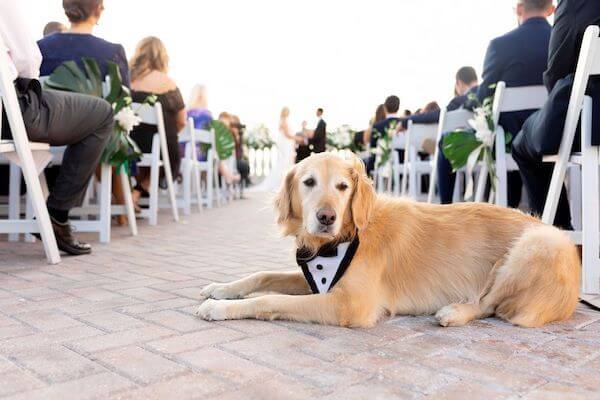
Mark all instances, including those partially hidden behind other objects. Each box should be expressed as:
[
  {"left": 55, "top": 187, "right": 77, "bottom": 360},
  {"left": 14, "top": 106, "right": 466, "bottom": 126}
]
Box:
[{"left": 45, "top": 58, "right": 156, "bottom": 172}]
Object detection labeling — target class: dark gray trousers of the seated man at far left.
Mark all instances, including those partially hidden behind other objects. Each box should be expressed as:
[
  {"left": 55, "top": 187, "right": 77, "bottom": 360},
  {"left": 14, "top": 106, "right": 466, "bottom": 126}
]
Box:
[{"left": 11, "top": 79, "right": 114, "bottom": 211}]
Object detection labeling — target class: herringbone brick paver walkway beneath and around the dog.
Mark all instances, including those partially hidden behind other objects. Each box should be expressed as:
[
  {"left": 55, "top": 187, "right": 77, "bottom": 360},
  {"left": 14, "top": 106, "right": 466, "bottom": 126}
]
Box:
[{"left": 0, "top": 192, "right": 600, "bottom": 400}]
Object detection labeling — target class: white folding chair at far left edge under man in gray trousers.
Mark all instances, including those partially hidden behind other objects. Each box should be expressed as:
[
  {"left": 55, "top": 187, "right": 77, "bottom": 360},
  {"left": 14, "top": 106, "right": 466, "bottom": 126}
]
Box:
[{"left": 0, "top": 37, "right": 60, "bottom": 264}]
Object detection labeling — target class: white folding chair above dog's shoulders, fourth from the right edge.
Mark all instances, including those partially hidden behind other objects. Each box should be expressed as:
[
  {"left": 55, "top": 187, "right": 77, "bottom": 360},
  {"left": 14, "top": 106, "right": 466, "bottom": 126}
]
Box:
[{"left": 392, "top": 120, "right": 439, "bottom": 200}]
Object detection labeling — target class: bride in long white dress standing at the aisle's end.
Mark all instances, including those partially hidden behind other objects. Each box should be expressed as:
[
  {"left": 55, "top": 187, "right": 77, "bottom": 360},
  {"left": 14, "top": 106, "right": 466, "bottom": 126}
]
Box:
[{"left": 249, "top": 107, "right": 296, "bottom": 192}]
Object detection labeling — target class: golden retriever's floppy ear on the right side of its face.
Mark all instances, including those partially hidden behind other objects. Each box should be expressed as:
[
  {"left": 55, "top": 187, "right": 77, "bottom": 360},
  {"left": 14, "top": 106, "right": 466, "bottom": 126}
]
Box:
[{"left": 350, "top": 157, "right": 375, "bottom": 231}]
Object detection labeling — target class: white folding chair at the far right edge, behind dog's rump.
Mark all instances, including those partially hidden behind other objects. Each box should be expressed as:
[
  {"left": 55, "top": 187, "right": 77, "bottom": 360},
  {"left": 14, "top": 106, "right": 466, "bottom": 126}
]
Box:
[{"left": 542, "top": 26, "right": 600, "bottom": 294}]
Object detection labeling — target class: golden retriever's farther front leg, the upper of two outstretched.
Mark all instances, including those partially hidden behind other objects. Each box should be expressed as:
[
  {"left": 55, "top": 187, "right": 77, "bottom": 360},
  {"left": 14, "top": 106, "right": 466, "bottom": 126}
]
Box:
[{"left": 200, "top": 271, "right": 311, "bottom": 300}]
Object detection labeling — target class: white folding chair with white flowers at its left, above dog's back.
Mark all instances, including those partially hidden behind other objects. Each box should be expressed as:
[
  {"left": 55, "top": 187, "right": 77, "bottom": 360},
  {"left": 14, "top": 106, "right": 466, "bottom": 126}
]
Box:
[{"left": 475, "top": 81, "right": 548, "bottom": 207}]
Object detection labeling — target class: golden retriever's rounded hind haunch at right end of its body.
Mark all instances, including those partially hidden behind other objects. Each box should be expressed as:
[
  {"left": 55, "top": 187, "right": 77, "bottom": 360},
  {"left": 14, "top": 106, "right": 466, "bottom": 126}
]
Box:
[{"left": 480, "top": 225, "right": 581, "bottom": 327}]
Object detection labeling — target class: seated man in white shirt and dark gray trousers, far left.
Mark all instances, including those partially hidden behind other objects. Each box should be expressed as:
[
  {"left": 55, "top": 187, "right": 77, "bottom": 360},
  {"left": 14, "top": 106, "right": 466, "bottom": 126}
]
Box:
[{"left": 0, "top": 0, "right": 114, "bottom": 255}]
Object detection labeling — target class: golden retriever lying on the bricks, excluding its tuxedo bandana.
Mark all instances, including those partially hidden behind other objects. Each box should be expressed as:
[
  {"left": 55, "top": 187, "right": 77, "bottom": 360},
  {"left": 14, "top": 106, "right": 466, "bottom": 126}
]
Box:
[{"left": 197, "top": 154, "right": 581, "bottom": 327}]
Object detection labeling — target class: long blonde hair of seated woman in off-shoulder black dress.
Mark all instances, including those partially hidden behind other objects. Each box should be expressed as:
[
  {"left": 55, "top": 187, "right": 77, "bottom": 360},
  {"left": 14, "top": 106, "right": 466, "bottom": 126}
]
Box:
[{"left": 129, "top": 36, "right": 169, "bottom": 81}]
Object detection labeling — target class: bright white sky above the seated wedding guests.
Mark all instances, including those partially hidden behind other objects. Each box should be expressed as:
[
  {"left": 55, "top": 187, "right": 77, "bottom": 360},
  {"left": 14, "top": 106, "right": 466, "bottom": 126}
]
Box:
[{"left": 29, "top": 0, "right": 544, "bottom": 134}]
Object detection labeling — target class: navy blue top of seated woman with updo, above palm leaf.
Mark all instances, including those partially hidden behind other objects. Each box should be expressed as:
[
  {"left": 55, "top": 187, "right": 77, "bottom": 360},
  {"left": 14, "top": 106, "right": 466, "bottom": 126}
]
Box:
[{"left": 38, "top": 32, "right": 129, "bottom": 87}]
